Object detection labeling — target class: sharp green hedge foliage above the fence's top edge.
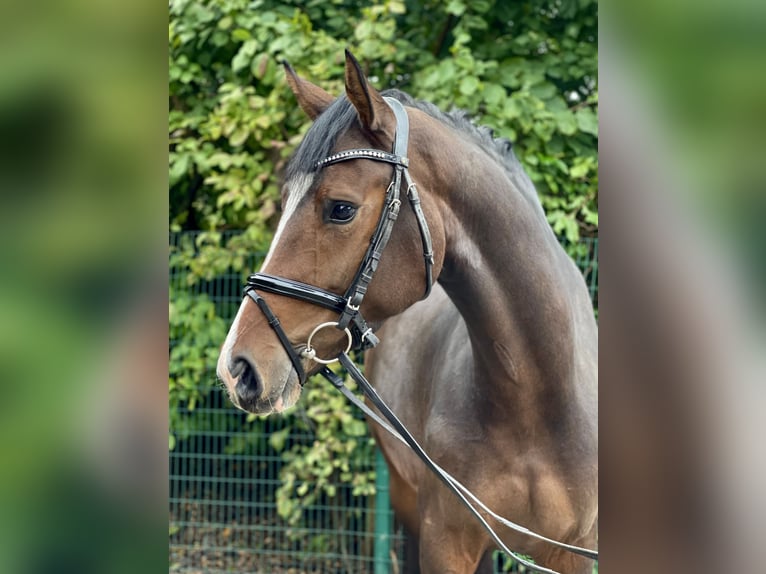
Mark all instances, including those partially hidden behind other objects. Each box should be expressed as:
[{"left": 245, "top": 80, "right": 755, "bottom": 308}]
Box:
[{"left": 169, "top": 0, "right": 598, "bottom": 242}]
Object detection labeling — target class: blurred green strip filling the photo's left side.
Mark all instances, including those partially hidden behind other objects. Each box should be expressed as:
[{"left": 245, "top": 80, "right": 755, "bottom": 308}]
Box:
[{"left": 0, "top": 0, "right": 168, "bottom": 573}]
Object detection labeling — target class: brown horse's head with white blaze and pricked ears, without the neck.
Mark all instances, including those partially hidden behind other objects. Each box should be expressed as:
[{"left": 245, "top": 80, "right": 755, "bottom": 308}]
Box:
[{"left": 218, "top": 52, "right": 444, "bottom": 413}]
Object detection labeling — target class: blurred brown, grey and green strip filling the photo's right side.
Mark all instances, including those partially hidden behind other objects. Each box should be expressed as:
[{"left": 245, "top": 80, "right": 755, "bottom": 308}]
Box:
[{"left": 599, "top": 1, "right": 766, "bottom": 572}]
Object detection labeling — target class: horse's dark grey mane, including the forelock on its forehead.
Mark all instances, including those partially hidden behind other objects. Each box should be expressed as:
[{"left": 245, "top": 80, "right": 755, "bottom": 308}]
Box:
[{"left": 285, "top": 89, "right": 542, "bottom": 215}]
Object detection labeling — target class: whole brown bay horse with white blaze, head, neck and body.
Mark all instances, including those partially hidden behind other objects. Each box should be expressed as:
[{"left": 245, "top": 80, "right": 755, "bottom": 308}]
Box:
[{"left": 217, "top": 51, "right": 598, "bottom": 574}]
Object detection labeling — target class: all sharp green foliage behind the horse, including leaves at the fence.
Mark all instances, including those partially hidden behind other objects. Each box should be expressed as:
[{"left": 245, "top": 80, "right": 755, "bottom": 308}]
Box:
[{"left": 169, "top": 0, "right": 598, "bottom": 536}]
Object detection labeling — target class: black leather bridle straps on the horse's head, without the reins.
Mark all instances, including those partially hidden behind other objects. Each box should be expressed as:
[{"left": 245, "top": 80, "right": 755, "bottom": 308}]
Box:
[{"left": 245, "top": 98, "right": 434, "bottom": 385}]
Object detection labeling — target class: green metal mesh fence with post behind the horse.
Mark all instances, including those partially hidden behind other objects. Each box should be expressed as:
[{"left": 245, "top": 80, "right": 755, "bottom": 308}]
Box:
[{"left": 169, "top": 232, "right": 598, "bottom": 574}]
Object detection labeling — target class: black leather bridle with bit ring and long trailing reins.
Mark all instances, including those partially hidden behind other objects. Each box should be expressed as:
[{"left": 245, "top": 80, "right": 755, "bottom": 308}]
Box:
[{"left": 237, "top": 98, "right": 598, "bottom": 574}]
